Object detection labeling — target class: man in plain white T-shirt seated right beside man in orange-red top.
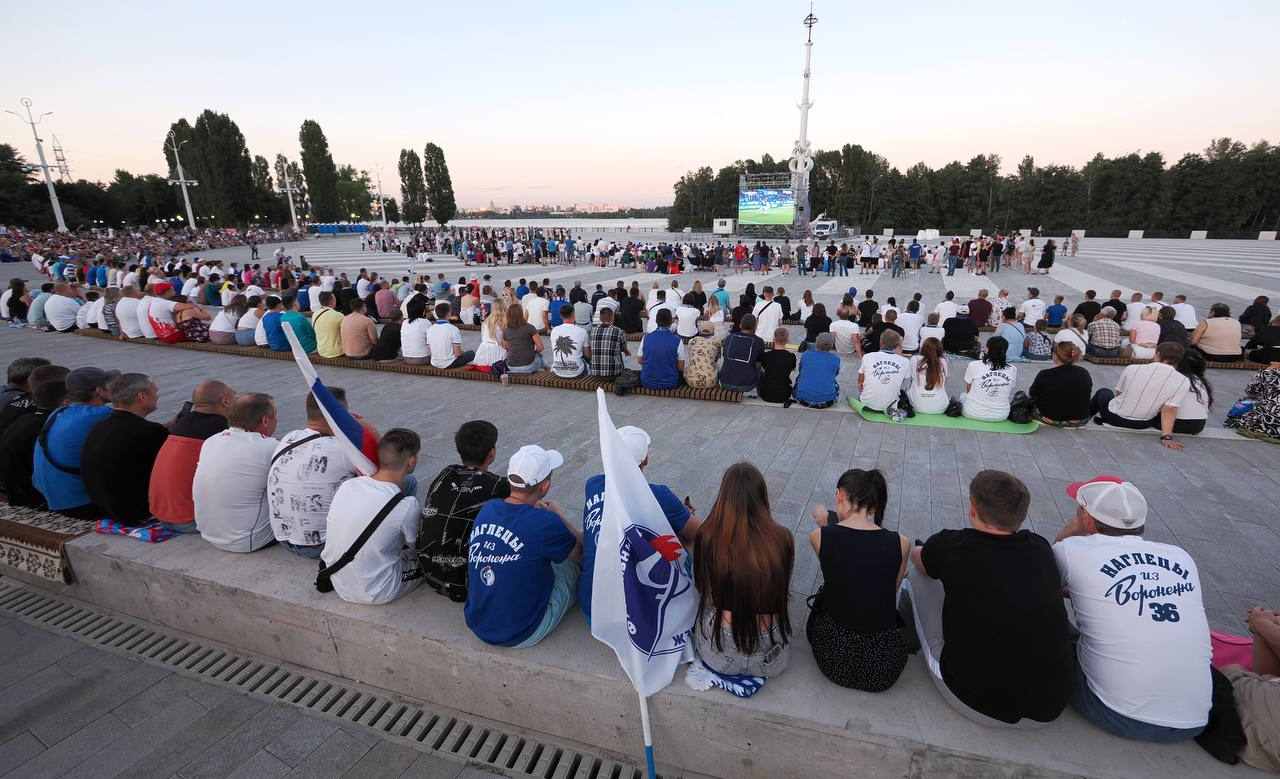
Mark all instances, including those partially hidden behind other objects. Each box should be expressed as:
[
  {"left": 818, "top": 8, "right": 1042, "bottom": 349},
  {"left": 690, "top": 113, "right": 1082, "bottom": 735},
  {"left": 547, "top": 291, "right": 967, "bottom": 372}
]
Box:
[{"left": 191, "top": 393, "right": 279, "bottom": 553}]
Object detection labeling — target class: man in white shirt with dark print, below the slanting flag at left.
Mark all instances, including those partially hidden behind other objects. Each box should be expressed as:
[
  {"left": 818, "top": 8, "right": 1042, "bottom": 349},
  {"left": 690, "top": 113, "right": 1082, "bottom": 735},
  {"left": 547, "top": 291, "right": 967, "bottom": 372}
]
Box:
[{"left": 266, "top": 386, "right": 358, "bottom": 559}]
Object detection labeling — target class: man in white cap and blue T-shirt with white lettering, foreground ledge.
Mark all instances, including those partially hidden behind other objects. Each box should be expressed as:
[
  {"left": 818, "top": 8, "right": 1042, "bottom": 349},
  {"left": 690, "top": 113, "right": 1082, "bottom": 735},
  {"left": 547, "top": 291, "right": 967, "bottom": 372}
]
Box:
[{"left": 466, "top": 445, "right": 582, "bottom": 649}]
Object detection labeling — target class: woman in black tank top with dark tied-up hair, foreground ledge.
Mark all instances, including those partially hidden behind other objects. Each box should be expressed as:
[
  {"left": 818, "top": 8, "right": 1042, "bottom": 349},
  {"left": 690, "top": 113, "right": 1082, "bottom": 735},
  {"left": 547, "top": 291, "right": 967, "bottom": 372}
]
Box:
[{"left": 805, "top": 468, "right": 910, "bottom": 692}]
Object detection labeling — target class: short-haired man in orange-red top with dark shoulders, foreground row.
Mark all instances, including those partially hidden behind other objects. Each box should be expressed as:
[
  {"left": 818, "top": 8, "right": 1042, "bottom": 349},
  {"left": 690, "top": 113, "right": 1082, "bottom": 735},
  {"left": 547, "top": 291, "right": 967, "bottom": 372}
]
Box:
[{"left": 148, "top": 380, "right": 236, "bottom": 533}]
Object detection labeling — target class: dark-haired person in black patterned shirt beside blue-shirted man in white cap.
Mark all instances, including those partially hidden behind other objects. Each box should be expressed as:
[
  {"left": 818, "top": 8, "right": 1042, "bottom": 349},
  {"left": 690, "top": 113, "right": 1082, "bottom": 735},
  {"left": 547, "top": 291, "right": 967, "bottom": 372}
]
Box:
[{"left": 417, "top": 420, "right": 511, "bottom": 602}]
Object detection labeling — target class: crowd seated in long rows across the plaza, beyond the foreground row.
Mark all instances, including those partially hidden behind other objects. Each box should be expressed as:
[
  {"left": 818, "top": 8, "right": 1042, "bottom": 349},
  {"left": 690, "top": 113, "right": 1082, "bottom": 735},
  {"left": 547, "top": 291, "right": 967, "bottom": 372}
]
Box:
[{"left": 0, "top": 234, "right": 1280, "bottom": 449}]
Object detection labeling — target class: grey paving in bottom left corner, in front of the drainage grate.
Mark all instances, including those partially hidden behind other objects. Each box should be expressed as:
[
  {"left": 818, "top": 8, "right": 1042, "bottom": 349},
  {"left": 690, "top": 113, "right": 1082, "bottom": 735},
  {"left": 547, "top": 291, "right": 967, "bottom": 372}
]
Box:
[{"left": 0, "top": 617, "right": 498, "bottom": 779}]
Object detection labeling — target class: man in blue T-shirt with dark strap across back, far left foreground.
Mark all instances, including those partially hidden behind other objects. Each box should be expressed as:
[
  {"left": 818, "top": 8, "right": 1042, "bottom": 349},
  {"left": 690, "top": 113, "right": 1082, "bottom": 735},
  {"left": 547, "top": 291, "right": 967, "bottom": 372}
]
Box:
[{"left": 31, "top": 367, "right": 116, "bottom": 519}]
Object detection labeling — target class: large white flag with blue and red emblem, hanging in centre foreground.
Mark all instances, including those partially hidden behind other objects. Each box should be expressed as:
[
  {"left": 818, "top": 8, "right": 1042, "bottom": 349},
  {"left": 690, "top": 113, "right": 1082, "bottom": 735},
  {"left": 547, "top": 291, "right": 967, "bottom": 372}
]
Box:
[{"left": 591, "top": 389, "right": 698, "bottom": 697}]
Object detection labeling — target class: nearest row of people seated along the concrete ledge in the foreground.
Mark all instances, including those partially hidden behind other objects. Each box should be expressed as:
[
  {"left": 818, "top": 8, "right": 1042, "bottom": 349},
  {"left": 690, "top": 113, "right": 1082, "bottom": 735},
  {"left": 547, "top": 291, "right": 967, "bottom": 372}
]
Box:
[{"left": 0, "top": 353, "right": 1280, "bottom": 770}]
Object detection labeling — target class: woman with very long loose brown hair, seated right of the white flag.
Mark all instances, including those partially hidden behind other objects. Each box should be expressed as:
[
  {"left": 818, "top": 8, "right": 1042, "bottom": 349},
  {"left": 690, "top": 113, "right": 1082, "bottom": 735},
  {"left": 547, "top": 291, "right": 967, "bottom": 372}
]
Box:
[{"left": 694, "top": 462, "right": 795, "bottom": 677}]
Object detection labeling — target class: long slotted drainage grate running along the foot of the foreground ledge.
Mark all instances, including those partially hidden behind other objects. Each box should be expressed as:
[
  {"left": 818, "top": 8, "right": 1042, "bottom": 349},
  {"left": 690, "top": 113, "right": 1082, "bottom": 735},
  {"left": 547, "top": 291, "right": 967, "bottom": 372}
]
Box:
[{"left": 0, "top": 581, "right": 675, "bottom": 779}]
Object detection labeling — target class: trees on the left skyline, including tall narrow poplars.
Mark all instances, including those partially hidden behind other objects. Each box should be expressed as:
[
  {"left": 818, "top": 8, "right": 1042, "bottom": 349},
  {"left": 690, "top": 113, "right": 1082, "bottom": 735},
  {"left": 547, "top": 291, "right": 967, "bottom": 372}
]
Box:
[{"left": 0, "top": 109, "right": 457, "bottom": 229}]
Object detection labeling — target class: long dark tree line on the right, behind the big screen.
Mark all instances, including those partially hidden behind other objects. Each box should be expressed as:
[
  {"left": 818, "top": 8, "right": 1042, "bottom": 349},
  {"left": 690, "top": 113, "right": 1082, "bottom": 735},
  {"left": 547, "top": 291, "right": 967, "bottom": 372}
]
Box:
[{"left": 668, "top": 138, "right": 1280, "bottom": 237}]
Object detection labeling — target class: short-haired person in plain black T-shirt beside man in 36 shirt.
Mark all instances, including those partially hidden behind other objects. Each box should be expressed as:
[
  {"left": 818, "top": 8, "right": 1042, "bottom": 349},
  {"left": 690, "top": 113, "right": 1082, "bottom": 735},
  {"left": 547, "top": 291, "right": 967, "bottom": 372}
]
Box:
[{"left": 908, "top": 471, "right": 1074, "bottom": 727}]
